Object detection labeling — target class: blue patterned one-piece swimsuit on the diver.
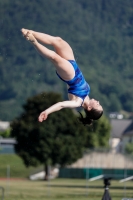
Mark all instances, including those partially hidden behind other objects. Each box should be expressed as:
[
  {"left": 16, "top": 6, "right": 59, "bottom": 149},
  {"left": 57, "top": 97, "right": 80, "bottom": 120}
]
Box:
[{"left": 56, "top": 60, "right": 90, "bottom": 104}]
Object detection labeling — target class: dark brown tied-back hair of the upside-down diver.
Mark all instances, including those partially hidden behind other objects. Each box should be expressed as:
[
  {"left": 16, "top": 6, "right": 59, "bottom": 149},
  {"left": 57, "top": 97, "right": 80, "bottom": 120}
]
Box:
[{"left": 78, "top": 108, "right": 103, "bottom": 126}]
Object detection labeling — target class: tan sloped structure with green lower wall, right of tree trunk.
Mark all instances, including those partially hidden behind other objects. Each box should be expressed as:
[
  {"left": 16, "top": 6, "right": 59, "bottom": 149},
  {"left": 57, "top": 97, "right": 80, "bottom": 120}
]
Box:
[{"left": 59, "top": 151, "right": 133, "bottom": 179}]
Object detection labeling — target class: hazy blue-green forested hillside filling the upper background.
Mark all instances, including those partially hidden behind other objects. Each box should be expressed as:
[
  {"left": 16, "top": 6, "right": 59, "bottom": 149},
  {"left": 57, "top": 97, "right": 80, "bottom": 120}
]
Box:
[{"left": 0, "top": 0, "right": 133, "bottom": 120}]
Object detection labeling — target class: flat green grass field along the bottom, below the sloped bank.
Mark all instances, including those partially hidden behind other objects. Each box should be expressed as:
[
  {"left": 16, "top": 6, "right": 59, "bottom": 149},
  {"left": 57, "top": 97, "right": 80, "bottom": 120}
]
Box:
[{"left": 0, "top": 179, "right": 133, "bottom": 200}]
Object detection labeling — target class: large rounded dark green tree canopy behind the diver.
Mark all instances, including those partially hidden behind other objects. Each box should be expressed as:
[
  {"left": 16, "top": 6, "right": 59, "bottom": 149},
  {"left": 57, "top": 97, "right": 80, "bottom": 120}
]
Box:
[{"left": 11, "top": 92, "right": 110, "bottom": 169}]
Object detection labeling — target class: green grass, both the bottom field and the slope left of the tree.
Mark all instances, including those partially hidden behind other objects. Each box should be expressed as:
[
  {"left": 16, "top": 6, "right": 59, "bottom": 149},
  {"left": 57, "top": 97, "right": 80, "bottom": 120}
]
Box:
[{"left": 0, "top": 154, "right": 133, "bottom": 200}]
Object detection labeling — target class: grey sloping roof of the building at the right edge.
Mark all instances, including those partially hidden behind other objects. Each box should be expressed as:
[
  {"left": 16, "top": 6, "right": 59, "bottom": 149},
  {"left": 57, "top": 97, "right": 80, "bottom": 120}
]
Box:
[{"left": 111, "top": 119, "right": 133, "bottom": 138}]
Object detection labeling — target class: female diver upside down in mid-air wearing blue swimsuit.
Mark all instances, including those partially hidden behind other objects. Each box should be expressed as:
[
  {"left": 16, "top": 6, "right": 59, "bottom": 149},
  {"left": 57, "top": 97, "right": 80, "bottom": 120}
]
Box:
[{"left": 21, "top": 28, "right": 103, "bottom": 125}]
